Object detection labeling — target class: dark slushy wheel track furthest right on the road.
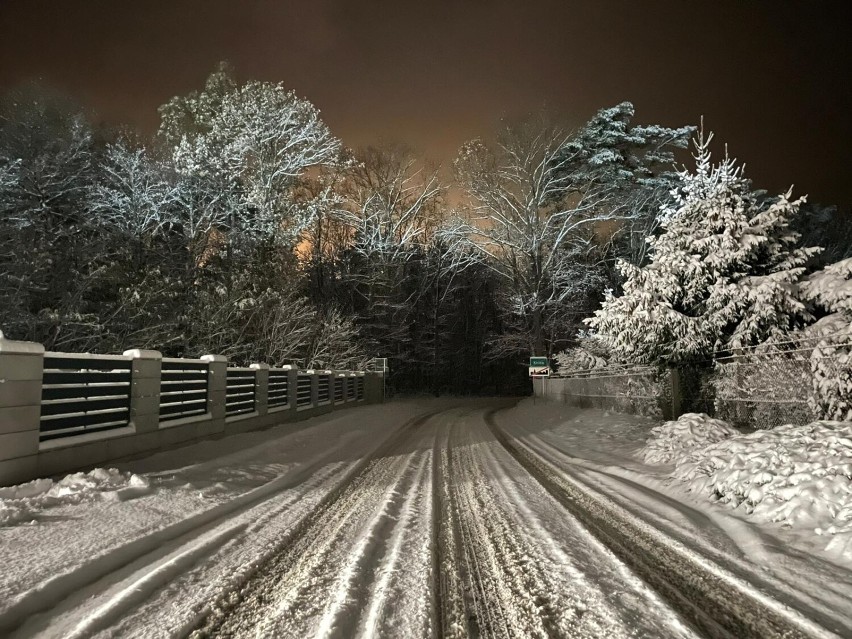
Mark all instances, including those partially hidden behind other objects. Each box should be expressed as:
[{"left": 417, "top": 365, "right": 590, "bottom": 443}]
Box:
[{"left": 486, "top": 411, "right": 833, "bottom": 639}]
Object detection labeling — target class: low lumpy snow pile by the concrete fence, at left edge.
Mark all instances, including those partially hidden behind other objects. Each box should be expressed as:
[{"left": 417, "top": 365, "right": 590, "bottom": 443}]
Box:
[{"left": 0, "top": 468, "right": 151, "bottom": 526}]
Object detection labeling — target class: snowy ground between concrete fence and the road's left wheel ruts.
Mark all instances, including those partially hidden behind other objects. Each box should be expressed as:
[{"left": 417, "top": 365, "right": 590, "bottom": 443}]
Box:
[{"left": 0, "top": 401, "right": 456, "bottom": 637}]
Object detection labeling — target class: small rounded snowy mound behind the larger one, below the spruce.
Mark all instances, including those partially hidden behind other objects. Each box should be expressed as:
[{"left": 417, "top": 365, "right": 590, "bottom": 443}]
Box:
[{"left": 642, "top": 413, "right": 739, "bottom": 464}]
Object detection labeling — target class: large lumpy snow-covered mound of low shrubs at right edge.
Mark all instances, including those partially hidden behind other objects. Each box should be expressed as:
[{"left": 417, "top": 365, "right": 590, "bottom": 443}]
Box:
[{"left": 672, "top": 421, "right": 852, "bottom": 558}]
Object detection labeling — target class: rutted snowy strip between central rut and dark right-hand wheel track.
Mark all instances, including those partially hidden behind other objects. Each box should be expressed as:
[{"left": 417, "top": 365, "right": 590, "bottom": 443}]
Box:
[{"left": 450, "top": 411, "right": 693, "bottom": 638}]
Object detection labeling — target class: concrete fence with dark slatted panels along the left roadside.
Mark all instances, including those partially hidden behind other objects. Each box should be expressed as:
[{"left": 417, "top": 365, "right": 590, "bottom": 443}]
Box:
[{"left": 0, "top": 333, "right": 384, "bottom": 485}]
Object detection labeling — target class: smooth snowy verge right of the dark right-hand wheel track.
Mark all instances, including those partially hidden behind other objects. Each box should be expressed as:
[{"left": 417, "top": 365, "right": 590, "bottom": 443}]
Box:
[{"left": 497, "top": 400, "right": 852, "bottom": 636}]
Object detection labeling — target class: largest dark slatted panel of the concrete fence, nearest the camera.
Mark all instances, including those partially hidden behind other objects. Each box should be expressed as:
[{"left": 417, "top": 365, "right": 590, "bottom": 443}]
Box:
[{"left": 39, "top": 352, "right": 132, "bottom": 441}]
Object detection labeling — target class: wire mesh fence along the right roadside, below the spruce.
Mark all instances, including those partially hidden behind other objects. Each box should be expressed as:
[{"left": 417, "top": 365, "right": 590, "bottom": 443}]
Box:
[{"left": 541, "top": 338, "right": 852, "bottom": 430}]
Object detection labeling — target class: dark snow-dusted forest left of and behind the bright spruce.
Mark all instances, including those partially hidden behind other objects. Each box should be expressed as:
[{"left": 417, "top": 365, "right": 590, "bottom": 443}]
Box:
[{"left": 0, "top": 66, "right": 842, "bottom": 393}]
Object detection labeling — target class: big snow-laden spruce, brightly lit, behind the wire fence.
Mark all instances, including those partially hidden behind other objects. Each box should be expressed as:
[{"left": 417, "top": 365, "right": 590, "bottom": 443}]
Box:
[{"left": 586, "top": 126, "right": 819, "bottom": 364}]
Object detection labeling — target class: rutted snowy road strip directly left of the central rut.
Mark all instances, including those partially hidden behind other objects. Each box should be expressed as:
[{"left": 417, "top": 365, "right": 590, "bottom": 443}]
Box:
[{"left": 194, "top": 411, "right": 446, "bottom": 636}]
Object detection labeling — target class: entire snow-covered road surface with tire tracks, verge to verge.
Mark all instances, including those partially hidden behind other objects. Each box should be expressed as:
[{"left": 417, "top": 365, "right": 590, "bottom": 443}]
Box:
[{"left": 0, "top": 400, "right": 852, "bottom": 638}]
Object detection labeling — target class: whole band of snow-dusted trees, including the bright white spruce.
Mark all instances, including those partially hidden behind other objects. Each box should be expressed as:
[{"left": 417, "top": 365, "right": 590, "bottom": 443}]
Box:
[{"left": 0, "top": 64, "right": 852, "bottom": 394}]
